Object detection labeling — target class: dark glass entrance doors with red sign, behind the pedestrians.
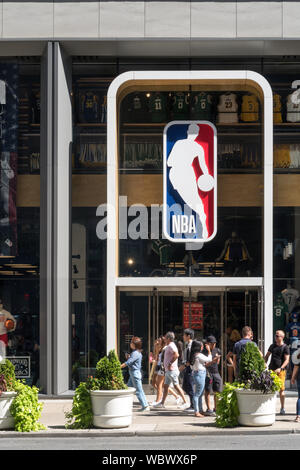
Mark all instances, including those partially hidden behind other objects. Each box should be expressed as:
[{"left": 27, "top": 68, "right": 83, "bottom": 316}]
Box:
[{"left": 118, "top": 287, "right": 264, "bottom": 383}]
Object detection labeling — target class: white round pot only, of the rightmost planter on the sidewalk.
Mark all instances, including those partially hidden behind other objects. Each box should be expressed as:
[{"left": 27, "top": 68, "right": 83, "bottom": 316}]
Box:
[{"left": 236, "top": 390, "right": 276, "bottom": 426}]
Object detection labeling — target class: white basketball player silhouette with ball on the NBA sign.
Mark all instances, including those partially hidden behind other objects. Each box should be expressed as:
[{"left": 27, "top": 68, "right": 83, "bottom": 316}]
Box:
[{"left": 167, "top": 124, "right": 214, "bottom": 239}]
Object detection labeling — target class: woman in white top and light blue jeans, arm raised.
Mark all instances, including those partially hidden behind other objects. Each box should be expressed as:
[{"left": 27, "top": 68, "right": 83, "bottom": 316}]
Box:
[{"left": 191, "top": 340, "right": 218, "bottom": 418}]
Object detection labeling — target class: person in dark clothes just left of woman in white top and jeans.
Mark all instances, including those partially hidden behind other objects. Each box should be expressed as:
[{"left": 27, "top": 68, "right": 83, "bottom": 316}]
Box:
[{"left": 180, "top": 328, "right": 194, "bottom": 413}]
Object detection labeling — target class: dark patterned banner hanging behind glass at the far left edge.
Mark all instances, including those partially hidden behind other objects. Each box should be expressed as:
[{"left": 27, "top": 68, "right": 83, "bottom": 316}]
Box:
[{"left": 0, "top": 63, "right": 19, "bottom": 257}]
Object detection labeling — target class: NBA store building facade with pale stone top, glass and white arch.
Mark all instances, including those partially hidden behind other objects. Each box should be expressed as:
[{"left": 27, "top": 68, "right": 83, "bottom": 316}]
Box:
[{"left": 0, "top": 1, "right": 300, "bottom": 395}]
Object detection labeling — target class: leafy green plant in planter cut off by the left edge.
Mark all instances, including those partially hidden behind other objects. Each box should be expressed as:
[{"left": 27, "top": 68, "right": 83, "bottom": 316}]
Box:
[{"left": 0, "top": 359, "right": 45, "bottom": 432}]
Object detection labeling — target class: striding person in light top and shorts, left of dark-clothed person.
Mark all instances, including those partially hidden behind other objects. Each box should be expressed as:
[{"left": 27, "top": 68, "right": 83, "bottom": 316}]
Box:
[{"left": 153, "top": 331, "right": 186, "bottom": 409}]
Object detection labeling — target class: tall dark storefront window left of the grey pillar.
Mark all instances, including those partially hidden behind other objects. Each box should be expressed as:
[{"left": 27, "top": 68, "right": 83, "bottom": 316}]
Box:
[{"left": 0, "top": 57, "right": 41, "bottom": 386}]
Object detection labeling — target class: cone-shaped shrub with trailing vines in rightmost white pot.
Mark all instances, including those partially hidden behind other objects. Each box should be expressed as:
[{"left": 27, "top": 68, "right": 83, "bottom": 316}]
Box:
[{"left": 216, "top": 342, "right": 281, "bottom": 427}]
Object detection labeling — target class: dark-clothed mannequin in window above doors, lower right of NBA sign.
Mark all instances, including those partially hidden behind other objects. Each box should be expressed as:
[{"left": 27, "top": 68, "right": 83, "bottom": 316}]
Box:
[{"left": 216, "top": 232, "right": 252, "bottom": 276}]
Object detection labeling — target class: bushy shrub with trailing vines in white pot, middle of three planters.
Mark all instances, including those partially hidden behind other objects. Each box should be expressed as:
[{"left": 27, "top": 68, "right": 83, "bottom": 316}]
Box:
[{"left": 66, "top": 350, "right": 135, "bottom": 429}]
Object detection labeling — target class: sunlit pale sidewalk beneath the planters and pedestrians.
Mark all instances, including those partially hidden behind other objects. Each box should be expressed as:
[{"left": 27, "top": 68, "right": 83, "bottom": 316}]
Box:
[{"left": 0, "top": 394, "right": 300, "bottom": 438}]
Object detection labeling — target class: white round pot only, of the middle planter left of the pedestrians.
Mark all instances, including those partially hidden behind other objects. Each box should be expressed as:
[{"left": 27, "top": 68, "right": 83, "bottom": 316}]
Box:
[{"left": 91, "top": 387, "right": 135, "bottom": 428}]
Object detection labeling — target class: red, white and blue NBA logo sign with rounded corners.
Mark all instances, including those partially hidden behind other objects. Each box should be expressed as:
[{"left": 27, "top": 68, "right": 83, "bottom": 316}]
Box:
[{"left": 163, "top": 121, "right": 217, "bottom": 243}]
